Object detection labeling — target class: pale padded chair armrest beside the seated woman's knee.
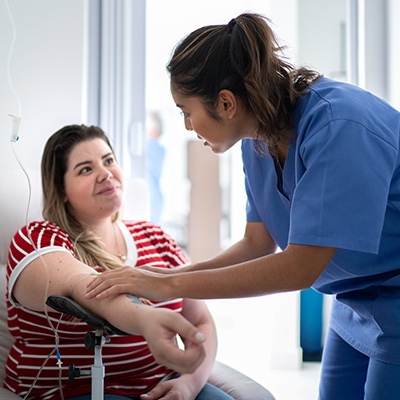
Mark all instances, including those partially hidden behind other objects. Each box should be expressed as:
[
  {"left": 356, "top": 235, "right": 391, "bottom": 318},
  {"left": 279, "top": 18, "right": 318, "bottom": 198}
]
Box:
[{"left": 208, "top": 361, "right": 275, "bottom": 400}]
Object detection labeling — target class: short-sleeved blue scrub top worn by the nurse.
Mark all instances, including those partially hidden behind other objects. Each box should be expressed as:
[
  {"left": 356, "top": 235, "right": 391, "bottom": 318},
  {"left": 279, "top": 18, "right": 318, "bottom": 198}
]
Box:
[{"left": 242, "top": 78, "right": 400, "bottom": 365}]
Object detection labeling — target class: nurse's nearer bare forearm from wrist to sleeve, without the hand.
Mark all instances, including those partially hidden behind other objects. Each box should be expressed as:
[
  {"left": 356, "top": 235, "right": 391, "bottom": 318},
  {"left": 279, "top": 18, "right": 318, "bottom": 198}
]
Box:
[{"left": 166, "top": 244, "right": 337, "bottom": 299}]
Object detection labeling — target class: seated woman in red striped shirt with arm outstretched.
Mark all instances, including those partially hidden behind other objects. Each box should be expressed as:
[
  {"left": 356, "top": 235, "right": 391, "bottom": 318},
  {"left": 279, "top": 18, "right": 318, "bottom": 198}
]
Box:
[{"left": 5, "top": 125, "right": 231, "bottom": 400}]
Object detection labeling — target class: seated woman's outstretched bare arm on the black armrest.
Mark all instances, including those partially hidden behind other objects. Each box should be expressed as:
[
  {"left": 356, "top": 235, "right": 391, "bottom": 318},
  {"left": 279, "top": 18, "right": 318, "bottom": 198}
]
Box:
[{"left": 13, "top": 252, "right": 205, "bottom": 373}]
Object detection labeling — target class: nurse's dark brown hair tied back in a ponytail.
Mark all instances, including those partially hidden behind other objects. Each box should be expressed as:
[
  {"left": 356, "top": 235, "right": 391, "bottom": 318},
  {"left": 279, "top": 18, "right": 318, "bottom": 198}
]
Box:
[{"left": 167, "top": 14, "right": 320, "bottom": 155}]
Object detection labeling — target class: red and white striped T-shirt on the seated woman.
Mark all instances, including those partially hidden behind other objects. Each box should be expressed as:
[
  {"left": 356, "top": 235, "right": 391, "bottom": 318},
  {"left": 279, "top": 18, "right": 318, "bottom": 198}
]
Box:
[{"left": 4, "top": 221, "right": 187, "bottom": 400}]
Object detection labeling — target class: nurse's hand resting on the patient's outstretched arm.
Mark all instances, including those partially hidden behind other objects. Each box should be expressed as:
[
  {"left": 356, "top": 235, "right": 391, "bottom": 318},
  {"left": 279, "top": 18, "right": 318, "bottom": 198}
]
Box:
[{"left": 85, "top": 266, "right": 170, "bottom": 301}]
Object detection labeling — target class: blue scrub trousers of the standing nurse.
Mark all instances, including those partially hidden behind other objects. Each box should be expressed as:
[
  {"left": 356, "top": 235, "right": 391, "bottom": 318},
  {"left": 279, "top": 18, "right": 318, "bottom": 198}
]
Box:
[{"left": 319, "top": 329, "right": 400, "bottom": 400}]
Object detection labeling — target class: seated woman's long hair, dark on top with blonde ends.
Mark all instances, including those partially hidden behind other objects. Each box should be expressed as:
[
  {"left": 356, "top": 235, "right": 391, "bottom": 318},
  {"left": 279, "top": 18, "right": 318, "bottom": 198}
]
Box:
[{"left": 41, "top": 125, "right": 123, "bottom": 270}]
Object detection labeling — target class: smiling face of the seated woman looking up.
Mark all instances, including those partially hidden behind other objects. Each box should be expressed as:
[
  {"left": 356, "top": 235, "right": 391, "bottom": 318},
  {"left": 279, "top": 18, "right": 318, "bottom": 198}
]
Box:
[{"left": 64, "top": 139, "right": 123, "bottom": 226}]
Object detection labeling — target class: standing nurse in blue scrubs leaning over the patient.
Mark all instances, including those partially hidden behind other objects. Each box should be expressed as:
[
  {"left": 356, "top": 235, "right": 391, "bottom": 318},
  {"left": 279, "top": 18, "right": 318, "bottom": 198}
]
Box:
[{"left": 86, "top": 14, "right": 400, "bottom": 400}]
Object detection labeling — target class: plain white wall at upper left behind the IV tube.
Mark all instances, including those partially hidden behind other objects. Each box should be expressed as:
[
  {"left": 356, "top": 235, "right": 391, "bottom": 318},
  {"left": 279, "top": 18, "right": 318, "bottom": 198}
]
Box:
[{"left": 0, "top": 0, "right": 85, "bottom": 168}]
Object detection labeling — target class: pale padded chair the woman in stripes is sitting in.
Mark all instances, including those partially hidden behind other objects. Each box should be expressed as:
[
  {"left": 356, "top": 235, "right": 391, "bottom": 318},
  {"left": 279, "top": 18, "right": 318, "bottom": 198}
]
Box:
[{"left": 0, "top": 168, "right": 274, "bottom": 400}]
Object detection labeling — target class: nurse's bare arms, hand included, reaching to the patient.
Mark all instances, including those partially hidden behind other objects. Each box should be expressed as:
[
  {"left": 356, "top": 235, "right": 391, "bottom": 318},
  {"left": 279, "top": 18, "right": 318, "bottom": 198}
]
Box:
[{"left": 86, "top": 222, "right": 336, "bottom": 301}]
